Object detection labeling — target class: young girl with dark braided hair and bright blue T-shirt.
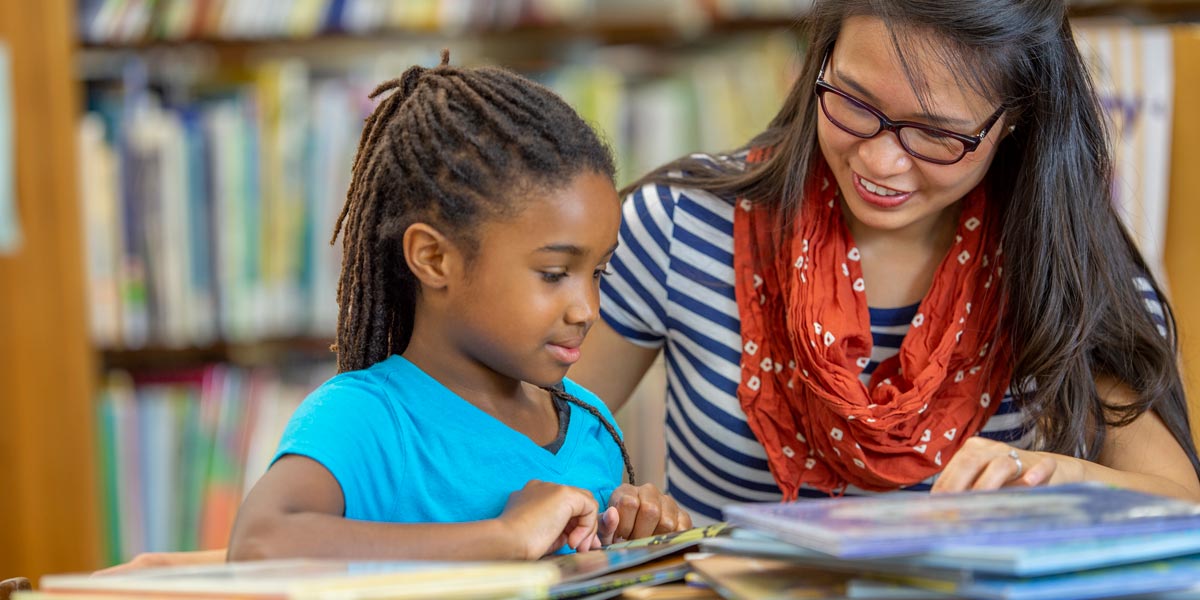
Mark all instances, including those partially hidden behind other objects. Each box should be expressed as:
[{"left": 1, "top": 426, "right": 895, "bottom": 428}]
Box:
[{"left": 229, "top": 53, "right": 691, "bottom": 560}]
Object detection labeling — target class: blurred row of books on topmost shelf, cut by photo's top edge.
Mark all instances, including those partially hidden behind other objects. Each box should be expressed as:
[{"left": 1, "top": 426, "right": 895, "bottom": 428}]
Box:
[{"left": 79, "top": 0, "right": 812, "bottom": 43}]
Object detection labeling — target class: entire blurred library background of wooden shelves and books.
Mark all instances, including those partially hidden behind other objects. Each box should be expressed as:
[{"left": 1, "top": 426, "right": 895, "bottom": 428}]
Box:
[{"left": 0, "top": 0, "right": 1200, "bottom": 578}]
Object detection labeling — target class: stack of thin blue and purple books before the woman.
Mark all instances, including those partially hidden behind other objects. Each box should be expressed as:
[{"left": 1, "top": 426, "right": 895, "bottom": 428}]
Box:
[{"left": 691, "top": 484, "right": 1200, "bottom": 600}]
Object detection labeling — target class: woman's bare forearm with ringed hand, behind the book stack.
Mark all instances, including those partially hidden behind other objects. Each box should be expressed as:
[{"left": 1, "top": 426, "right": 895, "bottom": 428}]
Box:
[{"left": 934, "top": 378, "right": 1200, "bottom": 500}]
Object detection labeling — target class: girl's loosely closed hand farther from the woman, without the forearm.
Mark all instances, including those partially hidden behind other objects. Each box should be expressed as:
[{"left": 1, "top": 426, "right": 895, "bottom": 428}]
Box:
[{"left": 497, "top": 480, "right": 600, "bottom": 559}]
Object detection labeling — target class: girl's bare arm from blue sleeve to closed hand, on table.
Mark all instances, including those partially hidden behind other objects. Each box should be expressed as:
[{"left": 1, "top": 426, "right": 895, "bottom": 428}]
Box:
[{"left": 229, "top": 455, "right": 609, "bottom": 560}]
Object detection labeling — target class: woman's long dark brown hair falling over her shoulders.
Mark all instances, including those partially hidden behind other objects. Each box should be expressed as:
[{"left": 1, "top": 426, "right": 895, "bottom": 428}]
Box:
[{"left": 622, "top": 0, "right": 1200, "bottom": 473}]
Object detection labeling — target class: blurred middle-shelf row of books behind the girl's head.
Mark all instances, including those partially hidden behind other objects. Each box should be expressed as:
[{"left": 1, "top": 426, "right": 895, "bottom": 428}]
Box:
[{"left": 79, "top": 34, "right": 796, "bottom": 348}]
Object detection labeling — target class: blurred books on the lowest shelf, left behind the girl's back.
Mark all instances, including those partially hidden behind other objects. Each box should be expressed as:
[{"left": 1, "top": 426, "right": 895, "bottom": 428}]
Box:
[{"left": 97, "top": 365, "right": 332, "bottom": 564}]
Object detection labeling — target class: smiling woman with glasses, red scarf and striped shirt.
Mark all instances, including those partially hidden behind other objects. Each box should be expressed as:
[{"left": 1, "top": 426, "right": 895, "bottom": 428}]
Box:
[{"left": 570, "top": 0, "right": 1200, "bottom": 521}]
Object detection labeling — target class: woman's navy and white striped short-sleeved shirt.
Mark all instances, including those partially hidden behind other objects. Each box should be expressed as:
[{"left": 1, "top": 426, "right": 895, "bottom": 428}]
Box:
[{"left": 600, "top": 156, "right": 1162, "bottom": 523}]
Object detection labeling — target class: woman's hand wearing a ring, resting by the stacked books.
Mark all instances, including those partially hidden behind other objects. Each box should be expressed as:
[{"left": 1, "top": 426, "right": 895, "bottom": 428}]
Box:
[{"left": 931, "top": 437, "right": 1065, "bottom": 492}]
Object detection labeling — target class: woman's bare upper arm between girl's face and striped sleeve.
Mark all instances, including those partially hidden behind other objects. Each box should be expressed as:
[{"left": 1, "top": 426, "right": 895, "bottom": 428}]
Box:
[{"left": 568, "top": 319, "right": 659, "bottom": 413}]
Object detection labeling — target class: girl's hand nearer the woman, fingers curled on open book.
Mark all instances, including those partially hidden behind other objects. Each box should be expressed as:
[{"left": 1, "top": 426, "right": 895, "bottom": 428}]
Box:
[{"left": 600, "top": 484, "right": 691, "bottom": 545}]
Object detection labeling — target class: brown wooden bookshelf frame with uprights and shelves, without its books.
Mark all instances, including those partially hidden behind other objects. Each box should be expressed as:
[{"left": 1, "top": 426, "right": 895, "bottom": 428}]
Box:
[{"left": 7, "top": 0, "right": 1200, "bottom": 577}]
